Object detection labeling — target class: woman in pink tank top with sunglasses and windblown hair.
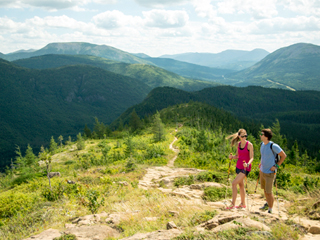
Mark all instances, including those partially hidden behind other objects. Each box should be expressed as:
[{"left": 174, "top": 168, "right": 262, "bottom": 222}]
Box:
[{"left": 227, "top": 129, "right": 253, "bottom": 209}]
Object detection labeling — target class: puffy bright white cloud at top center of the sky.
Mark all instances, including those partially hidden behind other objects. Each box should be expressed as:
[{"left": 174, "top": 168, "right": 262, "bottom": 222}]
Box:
[{"left": 143, "top": 9, "right": 189, "bottom": 28}]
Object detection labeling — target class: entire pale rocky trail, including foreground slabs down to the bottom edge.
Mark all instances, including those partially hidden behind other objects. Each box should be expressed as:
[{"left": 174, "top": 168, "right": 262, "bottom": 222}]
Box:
[{"left": 25, "top": 132, "right": 320, "bottom": 240}]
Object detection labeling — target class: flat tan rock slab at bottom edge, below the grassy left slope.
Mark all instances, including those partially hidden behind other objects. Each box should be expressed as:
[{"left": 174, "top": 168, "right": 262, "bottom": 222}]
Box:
[{"left": 65, "top": 225, "right": 119, "bottom": 240}]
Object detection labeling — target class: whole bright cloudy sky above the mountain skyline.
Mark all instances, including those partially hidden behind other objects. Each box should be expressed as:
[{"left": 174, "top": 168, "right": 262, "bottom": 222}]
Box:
[{"left": 0, "top": 0, "right": 320, "bottom": 57}]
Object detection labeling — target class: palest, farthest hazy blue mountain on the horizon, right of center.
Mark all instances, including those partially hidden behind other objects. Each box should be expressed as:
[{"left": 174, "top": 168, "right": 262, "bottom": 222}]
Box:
[{"left": 160, "top": 49, "right": 269, "bottom": 71}]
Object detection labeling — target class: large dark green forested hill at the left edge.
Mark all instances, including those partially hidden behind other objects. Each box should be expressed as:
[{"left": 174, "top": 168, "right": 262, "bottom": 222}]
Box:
[{"left": 0, "top": 60, "right": 150, "bottom": 171}]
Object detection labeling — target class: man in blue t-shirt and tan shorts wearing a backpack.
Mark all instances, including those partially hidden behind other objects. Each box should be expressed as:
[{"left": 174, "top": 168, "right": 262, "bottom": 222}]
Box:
[{"left": 259, "top": 129, "right": 287, "bottom": 213}]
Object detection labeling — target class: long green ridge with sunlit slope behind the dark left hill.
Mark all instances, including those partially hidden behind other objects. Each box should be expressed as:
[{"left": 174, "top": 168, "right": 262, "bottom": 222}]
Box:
[{"left": 14, "top": 55, "right": 219, "bottom": 91}]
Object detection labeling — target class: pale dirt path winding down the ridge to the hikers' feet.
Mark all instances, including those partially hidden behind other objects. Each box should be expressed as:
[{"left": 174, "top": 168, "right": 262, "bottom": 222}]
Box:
[{"left": 139, "top": 131, "right": 288, "bottom": 220}]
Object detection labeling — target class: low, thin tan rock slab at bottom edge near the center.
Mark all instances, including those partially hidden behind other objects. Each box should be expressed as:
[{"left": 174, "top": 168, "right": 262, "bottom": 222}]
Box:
[{"left": 121, "top": 229, "right": 183, "bottom": 240}]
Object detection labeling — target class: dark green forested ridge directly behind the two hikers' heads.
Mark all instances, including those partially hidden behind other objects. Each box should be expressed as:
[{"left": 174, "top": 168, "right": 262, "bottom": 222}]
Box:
[{"left": 112, "top": 86, "right": 320, "bottom": 158}]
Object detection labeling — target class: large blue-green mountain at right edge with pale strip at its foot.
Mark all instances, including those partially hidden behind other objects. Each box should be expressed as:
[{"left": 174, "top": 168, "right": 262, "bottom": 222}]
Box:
[{"left": 228, "top": 43, "right": 320, "bottom": 91}]
